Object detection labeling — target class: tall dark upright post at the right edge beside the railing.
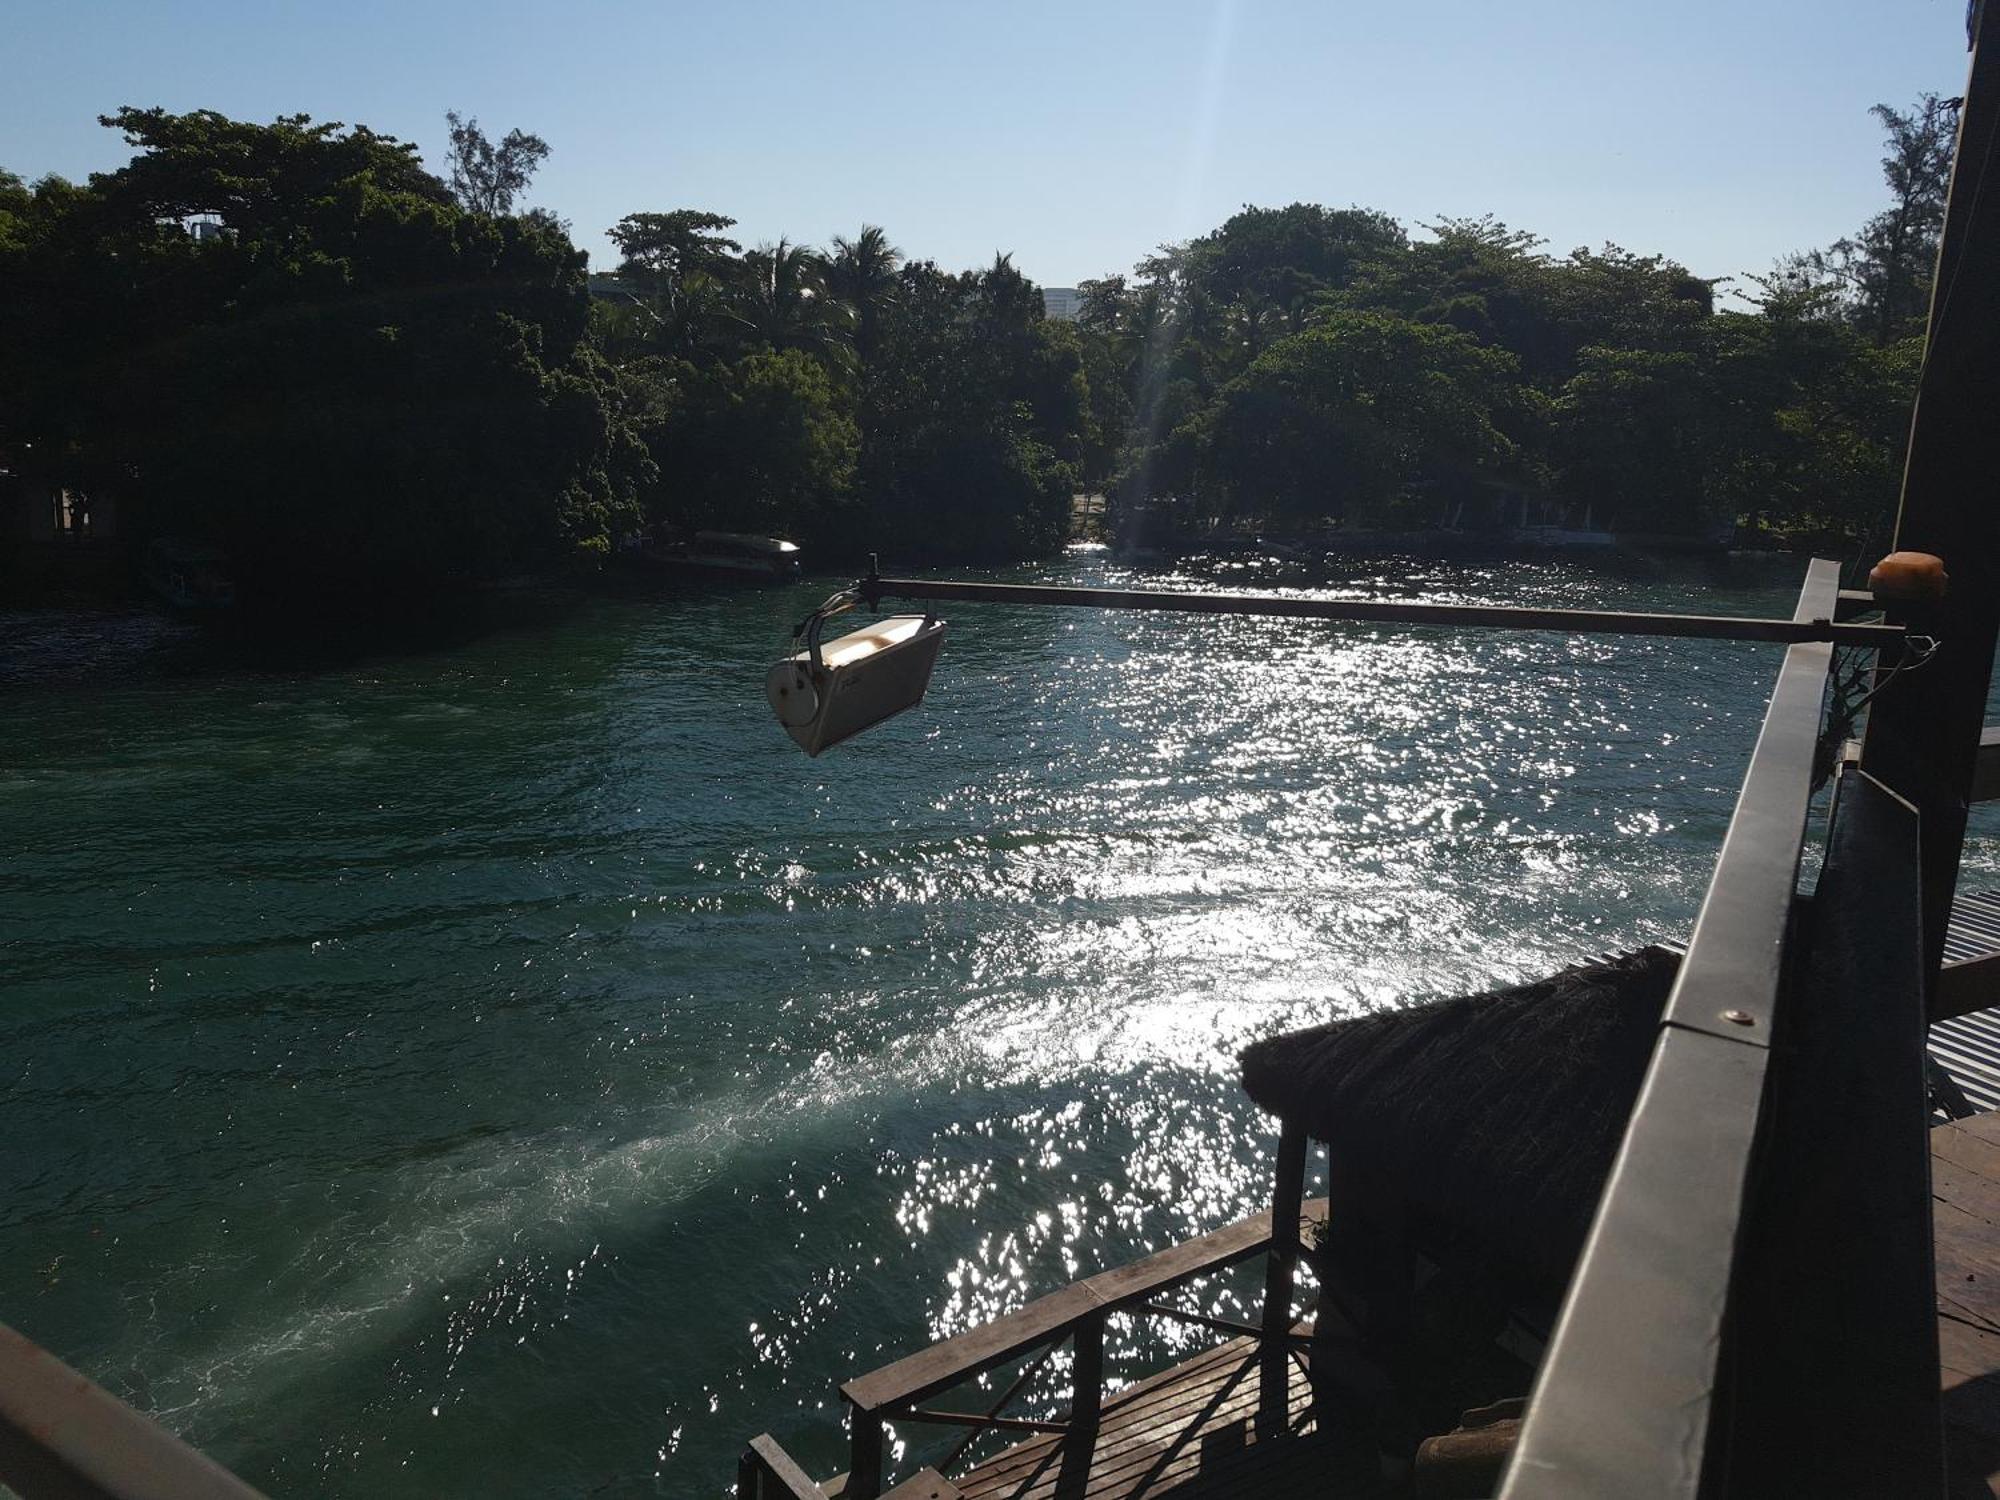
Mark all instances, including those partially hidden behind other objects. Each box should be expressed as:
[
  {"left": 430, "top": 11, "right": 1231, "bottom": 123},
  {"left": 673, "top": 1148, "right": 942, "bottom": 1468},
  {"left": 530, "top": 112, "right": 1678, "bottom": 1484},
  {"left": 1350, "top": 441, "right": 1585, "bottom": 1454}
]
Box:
[{"left": 1862, "top": 4, "right": 2000, "bottom": 1012}]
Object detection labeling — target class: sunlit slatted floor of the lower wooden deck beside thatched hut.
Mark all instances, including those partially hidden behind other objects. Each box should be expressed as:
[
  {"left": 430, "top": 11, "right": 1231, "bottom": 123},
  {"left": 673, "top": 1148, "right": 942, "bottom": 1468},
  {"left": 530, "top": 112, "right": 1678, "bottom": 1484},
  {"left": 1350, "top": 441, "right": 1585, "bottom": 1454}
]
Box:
[{"left": 956, "top": 1338, "right": 1332, "bottom": 1500}]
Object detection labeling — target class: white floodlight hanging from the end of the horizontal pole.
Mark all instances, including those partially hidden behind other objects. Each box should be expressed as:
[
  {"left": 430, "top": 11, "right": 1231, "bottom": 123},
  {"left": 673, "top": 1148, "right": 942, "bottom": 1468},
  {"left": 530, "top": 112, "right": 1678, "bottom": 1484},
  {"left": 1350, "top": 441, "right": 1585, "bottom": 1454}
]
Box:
[{"left": 764, "top": 594, "right": 944, "bottom": 756}]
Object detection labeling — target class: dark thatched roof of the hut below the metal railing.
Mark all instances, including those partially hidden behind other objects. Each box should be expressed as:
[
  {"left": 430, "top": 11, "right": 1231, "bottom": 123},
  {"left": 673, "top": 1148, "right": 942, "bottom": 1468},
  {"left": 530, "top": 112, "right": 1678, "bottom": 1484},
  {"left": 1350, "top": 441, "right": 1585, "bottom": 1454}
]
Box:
[{"left": 1242, "top": 948, "right": 1680, "bottom": 1294}]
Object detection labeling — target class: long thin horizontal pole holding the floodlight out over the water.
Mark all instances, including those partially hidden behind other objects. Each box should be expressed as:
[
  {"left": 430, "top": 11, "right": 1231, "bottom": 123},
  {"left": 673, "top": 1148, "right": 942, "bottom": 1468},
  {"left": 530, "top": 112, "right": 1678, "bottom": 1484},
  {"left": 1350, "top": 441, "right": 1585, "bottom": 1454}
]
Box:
[{"left": 854, "top": 574, "right": 1906, "bottom": 648}]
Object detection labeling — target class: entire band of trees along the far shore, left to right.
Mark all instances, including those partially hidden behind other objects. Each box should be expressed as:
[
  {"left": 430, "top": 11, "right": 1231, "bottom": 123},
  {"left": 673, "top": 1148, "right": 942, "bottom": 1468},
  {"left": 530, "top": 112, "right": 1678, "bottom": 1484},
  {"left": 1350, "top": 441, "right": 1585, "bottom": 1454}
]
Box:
[{"left": 0, "top": 96, "right": 1954, "bottom": 616}]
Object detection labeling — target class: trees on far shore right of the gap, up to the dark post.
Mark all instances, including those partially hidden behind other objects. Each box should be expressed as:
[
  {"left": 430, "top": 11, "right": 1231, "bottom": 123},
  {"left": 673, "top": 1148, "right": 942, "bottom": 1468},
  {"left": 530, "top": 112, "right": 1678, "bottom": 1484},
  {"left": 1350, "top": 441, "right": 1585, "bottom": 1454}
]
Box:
[{"left": 1082, "top": 96, "right": 1954, "bottom": 536}]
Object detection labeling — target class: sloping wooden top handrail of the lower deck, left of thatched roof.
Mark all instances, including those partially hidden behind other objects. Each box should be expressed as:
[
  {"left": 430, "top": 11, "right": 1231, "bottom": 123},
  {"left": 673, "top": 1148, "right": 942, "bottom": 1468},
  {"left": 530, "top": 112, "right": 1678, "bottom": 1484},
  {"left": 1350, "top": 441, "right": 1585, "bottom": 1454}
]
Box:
[{"left": 840, "top": 1200, "right": 1326, "bottom": 1412}]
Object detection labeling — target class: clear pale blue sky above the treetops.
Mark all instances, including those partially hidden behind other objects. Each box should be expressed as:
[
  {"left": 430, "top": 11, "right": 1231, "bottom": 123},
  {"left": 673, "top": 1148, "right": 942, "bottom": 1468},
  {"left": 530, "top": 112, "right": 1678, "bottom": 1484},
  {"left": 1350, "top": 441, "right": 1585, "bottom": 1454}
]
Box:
[{"left": 0, "top": 0, "right": 1966, "bottom": 286}]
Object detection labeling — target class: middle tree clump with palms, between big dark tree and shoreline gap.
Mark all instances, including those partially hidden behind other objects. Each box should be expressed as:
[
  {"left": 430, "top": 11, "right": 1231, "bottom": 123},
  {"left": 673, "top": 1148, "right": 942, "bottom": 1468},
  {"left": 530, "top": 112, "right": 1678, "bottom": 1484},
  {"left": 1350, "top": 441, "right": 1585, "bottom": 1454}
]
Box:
[{"left": 596, "top": 210, "right": 1090, "bottom": 562}]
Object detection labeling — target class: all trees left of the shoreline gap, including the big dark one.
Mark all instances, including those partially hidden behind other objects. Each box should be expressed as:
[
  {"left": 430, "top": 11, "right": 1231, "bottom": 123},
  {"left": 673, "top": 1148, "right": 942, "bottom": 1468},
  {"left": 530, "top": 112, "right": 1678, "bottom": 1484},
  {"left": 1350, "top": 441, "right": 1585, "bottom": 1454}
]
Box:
[{"left": 0, "top": 108, "right": 1086, "bottom": 598}]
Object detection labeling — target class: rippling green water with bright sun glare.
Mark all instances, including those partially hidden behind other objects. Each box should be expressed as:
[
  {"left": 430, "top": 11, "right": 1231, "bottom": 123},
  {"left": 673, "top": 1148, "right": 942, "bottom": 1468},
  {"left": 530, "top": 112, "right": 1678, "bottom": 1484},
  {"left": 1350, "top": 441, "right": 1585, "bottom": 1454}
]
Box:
[{"left": 0, "top": 556, "right": 1952, "bottom": 1496}]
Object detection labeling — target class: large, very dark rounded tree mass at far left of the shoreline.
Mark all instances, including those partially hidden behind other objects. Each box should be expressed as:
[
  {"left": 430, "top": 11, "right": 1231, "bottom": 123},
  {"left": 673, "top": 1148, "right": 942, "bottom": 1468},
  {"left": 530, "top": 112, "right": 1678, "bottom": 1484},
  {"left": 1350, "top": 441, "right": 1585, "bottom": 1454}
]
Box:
[{"left": 0, "top": 110, "right": 648, "bottom": 598}]
